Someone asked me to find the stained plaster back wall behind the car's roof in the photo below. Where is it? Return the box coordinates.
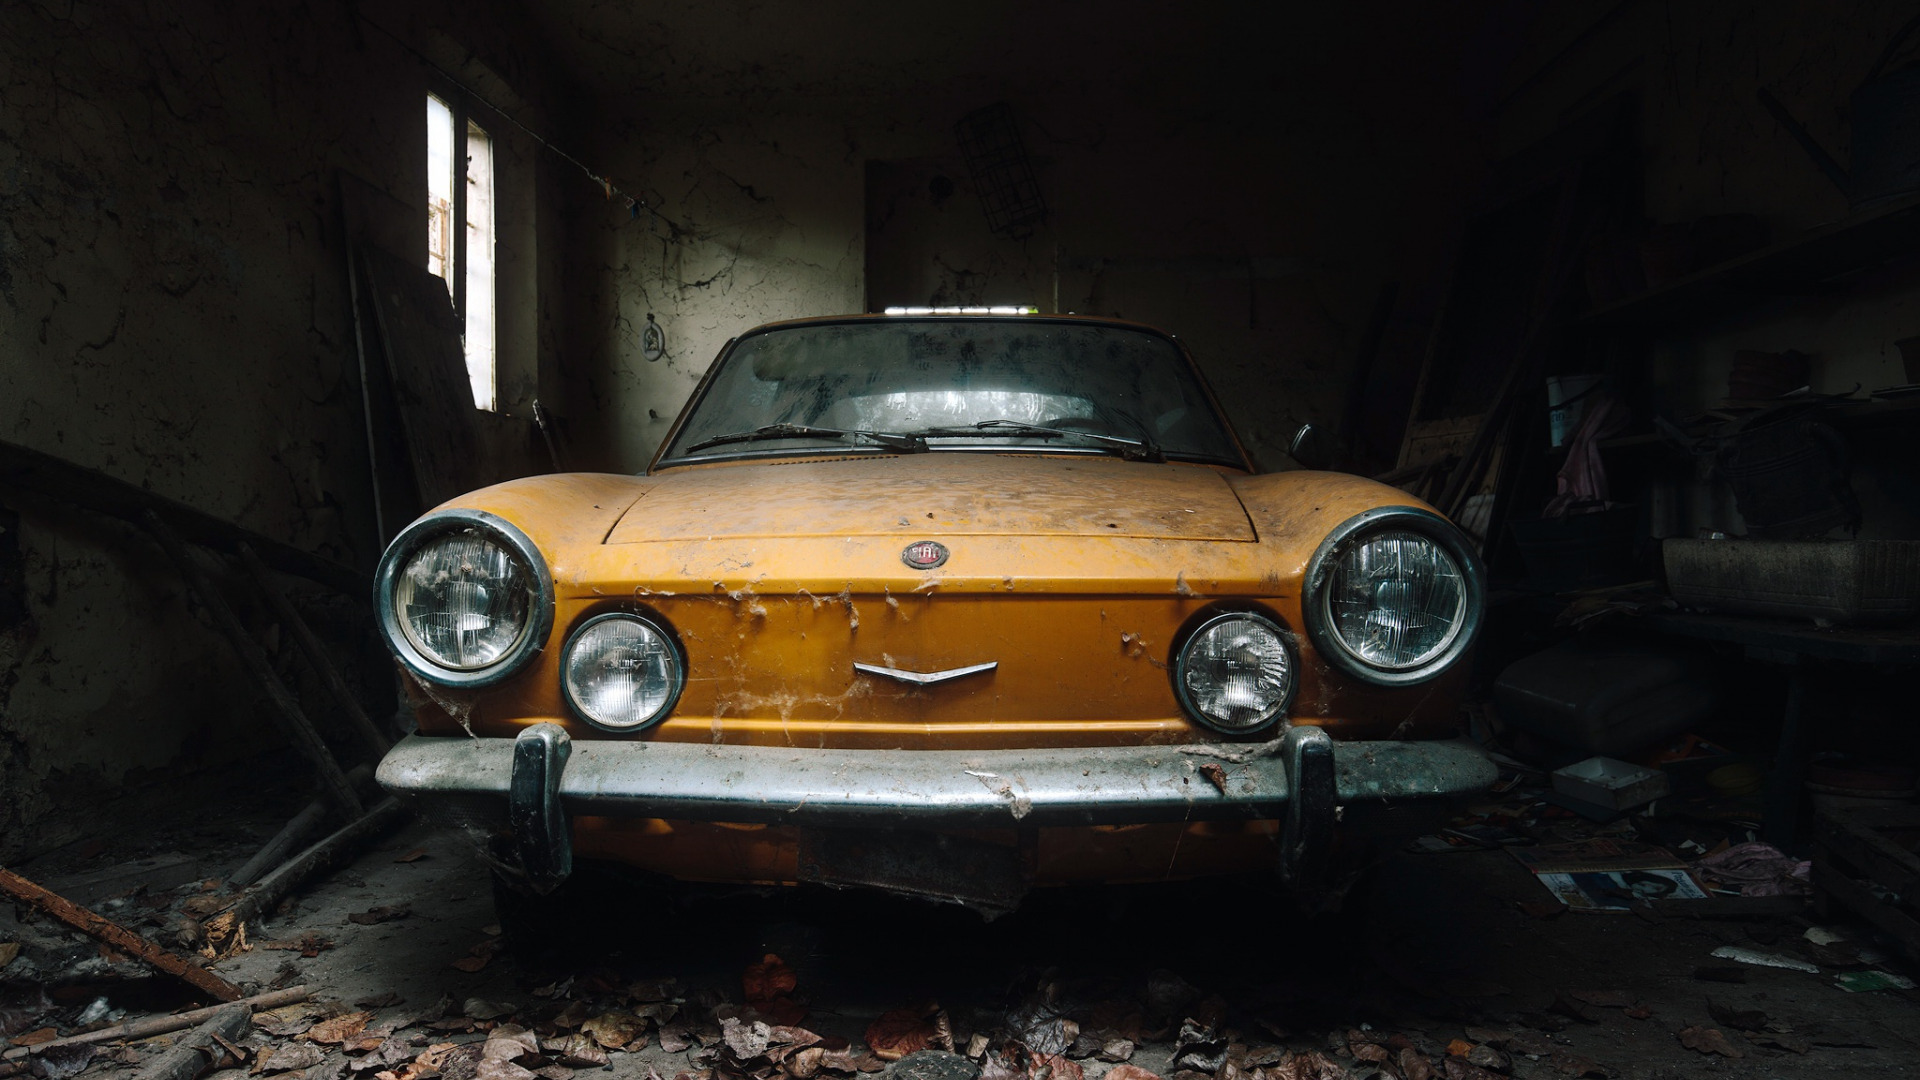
[553,0,1496,471]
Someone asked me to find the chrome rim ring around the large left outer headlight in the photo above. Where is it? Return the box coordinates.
[372,509,553,690]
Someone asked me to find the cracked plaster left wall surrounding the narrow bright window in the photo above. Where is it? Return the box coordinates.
[0,0,576,859]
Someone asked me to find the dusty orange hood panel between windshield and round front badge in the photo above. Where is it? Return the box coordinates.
[607,454,1256,544]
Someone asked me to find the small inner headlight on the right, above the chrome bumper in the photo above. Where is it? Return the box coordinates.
[1173,611,1294,734]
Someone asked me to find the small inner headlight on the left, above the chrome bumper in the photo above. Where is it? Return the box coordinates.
[564,613,685,732]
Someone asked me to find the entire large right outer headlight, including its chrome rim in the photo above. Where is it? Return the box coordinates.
[1308,507,1482,684]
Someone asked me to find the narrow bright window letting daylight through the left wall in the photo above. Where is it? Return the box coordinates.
[426,94,495,411]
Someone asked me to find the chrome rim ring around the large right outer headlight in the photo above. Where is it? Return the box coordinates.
[1302,505,1486,686]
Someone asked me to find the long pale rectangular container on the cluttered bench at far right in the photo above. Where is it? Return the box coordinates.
[1661,540,1920,625]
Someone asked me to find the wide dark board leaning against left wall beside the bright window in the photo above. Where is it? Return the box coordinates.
[361,248,484,507]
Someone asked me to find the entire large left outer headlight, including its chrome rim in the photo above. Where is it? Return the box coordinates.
[374,509,553,688]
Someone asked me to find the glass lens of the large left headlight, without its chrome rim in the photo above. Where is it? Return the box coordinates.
[394,528,534,671]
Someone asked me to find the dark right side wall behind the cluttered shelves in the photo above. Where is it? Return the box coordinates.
[1501,0,1920,538]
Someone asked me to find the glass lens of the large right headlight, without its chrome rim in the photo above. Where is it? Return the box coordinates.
[1327,530,1467,671]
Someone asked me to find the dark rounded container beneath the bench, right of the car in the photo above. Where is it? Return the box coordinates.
[1494,640,1718,755]
